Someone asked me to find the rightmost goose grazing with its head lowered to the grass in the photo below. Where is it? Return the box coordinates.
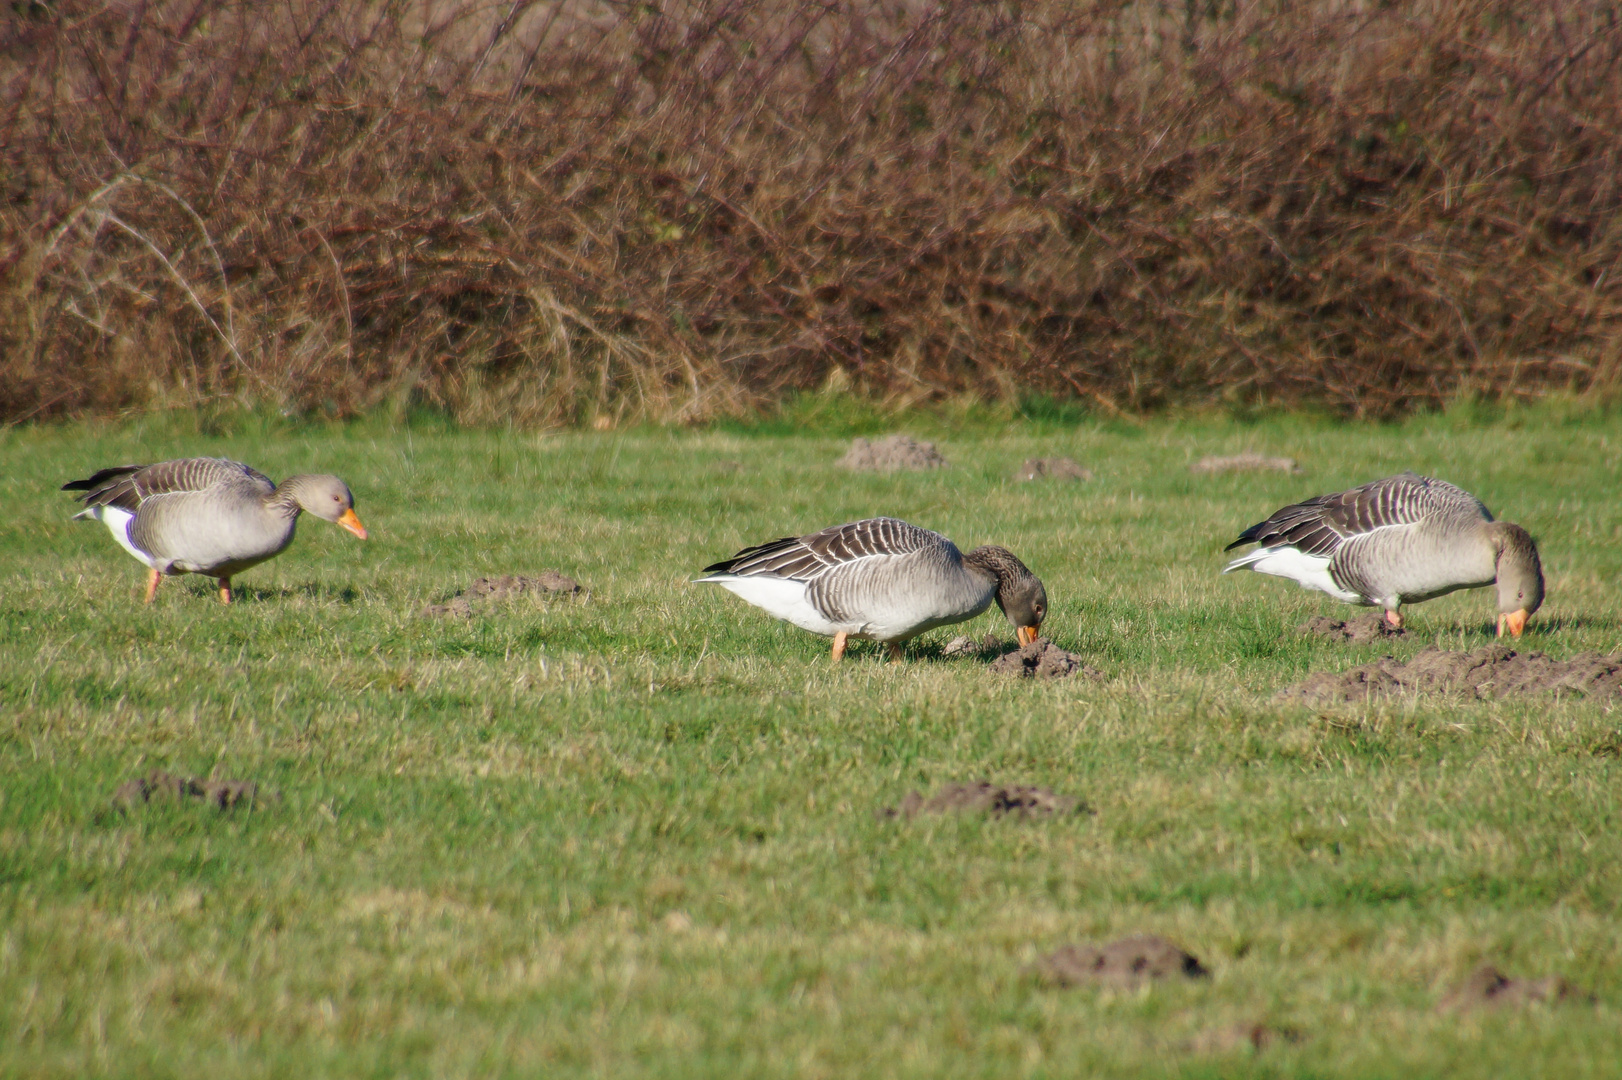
[1223,472,1543,637]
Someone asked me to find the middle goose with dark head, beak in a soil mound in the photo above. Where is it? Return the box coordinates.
[696,517,1048,662]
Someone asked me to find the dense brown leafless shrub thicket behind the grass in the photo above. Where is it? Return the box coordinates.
[0,0,1622,423]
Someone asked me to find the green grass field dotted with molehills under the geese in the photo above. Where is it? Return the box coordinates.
[0,410,1622,1077]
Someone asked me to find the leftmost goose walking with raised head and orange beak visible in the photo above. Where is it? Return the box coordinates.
[62,457,367,603]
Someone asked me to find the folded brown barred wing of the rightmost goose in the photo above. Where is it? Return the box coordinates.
[1225,472,1492,558]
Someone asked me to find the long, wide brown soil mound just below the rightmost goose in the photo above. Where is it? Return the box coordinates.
[1277,645,1622,705]
